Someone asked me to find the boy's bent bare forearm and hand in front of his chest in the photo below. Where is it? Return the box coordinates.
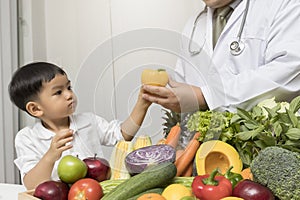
[23,130,73,190]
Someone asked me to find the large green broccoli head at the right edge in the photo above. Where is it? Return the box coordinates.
[250,146,300,200]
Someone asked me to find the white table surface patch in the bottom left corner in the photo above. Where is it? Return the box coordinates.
[0,183,26,200]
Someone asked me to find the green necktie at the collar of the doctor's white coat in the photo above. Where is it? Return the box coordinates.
[213,5,233,47]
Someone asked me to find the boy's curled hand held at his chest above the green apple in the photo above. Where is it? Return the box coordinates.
[47,129,73,161]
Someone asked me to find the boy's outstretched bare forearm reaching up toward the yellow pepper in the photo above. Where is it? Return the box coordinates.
[121,89,151,141]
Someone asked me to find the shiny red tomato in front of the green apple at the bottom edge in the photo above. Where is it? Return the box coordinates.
[68,178,103,200]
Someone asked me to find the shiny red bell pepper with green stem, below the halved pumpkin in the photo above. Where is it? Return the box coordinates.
[192,169,232,200]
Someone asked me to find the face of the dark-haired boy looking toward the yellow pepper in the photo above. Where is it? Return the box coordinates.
[37,74,77,120]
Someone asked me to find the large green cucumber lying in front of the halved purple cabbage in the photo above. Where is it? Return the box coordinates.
[101,162,177,200]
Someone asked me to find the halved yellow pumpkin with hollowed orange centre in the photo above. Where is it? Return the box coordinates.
[195,140,243,175]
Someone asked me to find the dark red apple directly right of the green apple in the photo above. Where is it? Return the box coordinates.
[83,155,110,182]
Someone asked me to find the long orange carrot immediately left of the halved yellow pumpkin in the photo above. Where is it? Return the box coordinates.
[175,132,200,176]
